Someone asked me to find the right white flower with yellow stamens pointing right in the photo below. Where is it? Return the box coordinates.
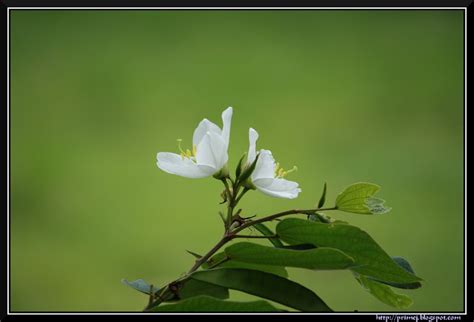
[247,128,301,199]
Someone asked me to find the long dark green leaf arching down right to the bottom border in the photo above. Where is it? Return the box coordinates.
[191,268,331,312]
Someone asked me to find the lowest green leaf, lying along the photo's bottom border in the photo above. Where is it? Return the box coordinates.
[151,295,279,312]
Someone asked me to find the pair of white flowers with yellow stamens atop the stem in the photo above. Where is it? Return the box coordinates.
[156,107,301,199]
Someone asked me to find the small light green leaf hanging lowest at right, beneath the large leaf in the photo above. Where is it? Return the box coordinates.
[356,275,413,309]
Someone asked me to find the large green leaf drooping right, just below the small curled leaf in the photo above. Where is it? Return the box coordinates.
[276,218,421,283]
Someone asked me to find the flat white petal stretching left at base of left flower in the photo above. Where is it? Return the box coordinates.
[156,152,214,178]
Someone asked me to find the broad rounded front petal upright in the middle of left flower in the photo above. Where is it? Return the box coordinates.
[196,132,228,172]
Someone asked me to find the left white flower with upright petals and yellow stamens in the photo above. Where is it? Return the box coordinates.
[156,107,232,178]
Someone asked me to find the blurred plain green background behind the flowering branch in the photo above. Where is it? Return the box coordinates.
[10,10,464,311]
